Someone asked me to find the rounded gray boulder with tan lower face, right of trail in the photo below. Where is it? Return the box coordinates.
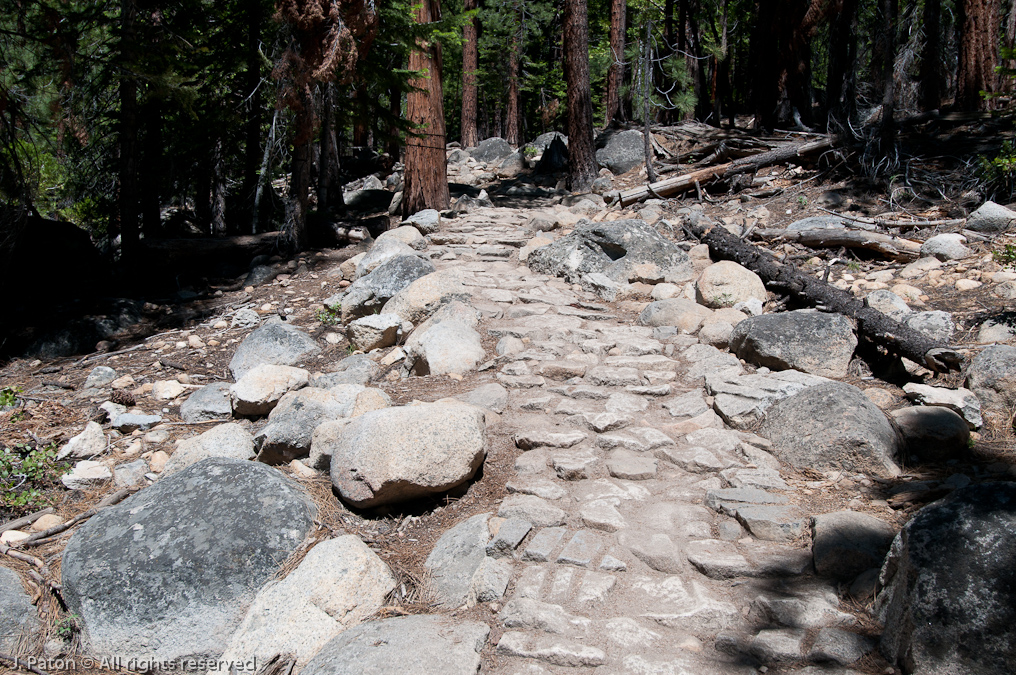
[763,382,900,477]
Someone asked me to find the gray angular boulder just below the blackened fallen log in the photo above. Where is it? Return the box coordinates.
[728,310,858,377]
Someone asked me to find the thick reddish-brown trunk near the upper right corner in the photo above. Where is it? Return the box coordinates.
[956,0,999,110]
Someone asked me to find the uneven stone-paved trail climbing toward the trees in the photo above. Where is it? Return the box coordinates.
[396,208,873,675]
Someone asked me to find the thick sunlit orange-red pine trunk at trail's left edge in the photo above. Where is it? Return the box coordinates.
[402,0,450,216]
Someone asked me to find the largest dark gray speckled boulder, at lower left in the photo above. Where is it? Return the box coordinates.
[61,458,317,661]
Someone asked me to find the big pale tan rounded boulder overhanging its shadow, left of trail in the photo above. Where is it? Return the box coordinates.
[325,404,487,507]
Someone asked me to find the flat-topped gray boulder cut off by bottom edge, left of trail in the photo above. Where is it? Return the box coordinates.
[301,614,491,675]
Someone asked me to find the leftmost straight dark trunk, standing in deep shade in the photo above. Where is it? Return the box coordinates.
[117,0,140,261]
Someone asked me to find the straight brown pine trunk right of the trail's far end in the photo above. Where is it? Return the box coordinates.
[563,0,596,192]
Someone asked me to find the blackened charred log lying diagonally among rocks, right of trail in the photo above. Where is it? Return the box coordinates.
[688,219,963,372]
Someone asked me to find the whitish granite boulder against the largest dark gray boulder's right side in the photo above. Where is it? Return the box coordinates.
[221,535,395,668]
